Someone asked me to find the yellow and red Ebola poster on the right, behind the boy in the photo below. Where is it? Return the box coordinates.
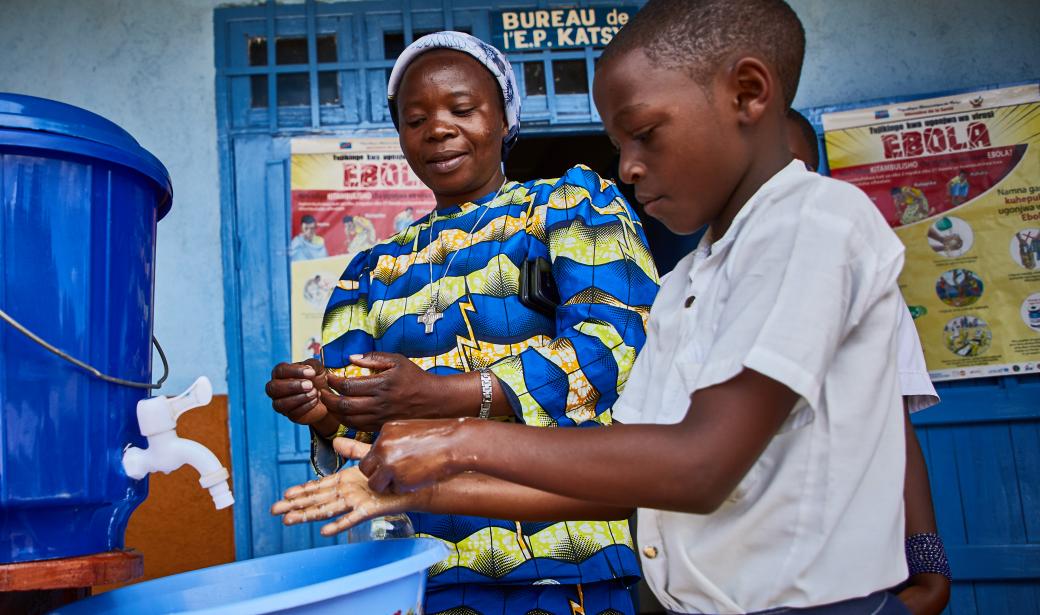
[823,83,1040,381]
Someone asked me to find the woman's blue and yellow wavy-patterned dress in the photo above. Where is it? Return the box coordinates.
[314,165,658,615]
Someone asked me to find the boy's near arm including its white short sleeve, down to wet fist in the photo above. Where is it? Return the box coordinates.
[360,194,902,513]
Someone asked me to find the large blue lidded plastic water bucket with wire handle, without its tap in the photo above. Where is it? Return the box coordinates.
[0,93,173,563]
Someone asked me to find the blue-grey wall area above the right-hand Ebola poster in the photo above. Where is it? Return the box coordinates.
[788,0,1040,108]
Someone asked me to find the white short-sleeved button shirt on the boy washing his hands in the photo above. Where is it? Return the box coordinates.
[614,161,915,613]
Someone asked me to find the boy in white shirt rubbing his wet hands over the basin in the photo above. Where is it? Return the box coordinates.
[272,0,919,613]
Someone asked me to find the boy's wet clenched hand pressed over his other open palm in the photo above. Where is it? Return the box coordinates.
[349,418,483,493]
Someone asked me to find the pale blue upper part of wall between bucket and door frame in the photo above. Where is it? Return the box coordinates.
[0,0,244,393]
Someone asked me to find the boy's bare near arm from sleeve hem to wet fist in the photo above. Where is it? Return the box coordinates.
[360,369,798,518]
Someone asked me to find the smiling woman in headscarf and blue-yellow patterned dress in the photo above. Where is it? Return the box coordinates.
[267,32,657,615]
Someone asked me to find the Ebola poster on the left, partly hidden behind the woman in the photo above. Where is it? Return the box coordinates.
[288,136,434,361]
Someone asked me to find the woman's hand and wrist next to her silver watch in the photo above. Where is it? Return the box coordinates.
[319,352,480,432]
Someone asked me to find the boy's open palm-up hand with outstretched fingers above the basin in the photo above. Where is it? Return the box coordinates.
[270,438,426,536]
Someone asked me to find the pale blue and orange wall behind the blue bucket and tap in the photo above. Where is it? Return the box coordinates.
[0,0,248,591]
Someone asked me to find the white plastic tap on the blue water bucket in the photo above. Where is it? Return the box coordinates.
[123,376,235,510]
